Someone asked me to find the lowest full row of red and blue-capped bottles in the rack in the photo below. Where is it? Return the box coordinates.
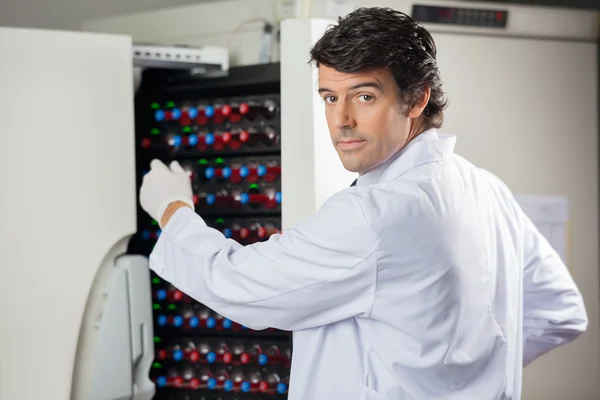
[154,367,289,395]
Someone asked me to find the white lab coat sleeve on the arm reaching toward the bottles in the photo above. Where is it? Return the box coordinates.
[150,189,377,330]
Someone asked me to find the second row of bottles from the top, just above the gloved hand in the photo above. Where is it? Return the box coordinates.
[141,126,279,151]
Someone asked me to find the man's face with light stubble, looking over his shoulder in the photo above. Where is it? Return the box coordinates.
[319,65,410,174]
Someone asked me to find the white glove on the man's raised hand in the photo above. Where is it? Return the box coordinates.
[140,160,194,228]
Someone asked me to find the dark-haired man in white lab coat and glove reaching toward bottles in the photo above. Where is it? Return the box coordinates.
[140,8,587,400]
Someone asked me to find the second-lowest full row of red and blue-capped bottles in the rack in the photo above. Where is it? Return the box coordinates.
[156,340,291,366]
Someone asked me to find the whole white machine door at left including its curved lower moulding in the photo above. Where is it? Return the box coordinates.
[0,28,154,400]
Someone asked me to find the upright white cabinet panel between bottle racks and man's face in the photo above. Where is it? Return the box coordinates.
[281,19,356,230]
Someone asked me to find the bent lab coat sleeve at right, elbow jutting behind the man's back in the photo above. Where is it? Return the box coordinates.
[519,210,588,366]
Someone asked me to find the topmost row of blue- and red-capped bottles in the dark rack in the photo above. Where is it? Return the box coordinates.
[150,99,279,125]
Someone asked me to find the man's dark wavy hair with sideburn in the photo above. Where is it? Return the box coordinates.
[310,7,447,128]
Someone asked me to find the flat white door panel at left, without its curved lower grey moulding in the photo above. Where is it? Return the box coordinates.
[0,28,136,400]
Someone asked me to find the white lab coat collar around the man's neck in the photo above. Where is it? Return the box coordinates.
[356,128,456,186]
